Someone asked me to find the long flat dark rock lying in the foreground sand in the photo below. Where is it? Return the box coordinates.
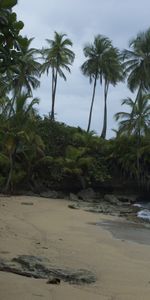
[0,255,96,284]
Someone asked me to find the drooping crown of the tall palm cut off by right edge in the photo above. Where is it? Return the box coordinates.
[122,28,150,99]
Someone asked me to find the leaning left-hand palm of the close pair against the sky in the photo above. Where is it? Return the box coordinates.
[81,35,111,132]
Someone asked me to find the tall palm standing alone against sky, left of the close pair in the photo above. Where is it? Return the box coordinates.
[41,31,75,120]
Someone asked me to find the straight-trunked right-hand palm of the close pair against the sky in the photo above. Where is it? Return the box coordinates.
[101,46,123,139]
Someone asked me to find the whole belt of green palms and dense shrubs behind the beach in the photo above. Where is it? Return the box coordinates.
[0,0,150,192]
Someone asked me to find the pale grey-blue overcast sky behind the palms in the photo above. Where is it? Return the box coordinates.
[14,0,150,138]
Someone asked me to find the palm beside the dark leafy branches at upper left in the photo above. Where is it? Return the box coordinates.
[8,38,40,116]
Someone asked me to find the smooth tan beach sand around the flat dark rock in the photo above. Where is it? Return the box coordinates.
[0,197,150,300]
